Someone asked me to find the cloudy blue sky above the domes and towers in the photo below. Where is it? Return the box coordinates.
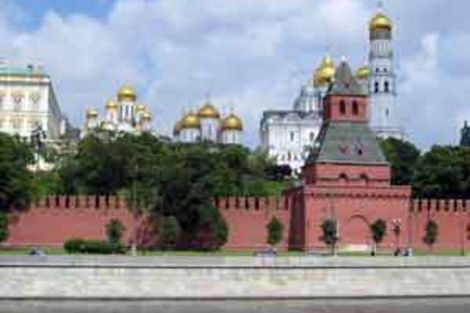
[0,0,470,148]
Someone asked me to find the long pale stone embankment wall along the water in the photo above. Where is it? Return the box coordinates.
[0,257,470,300]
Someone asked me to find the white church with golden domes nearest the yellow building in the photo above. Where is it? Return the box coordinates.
[81,85,152,137]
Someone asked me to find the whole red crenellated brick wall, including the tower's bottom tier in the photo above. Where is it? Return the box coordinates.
[4,193,470,251]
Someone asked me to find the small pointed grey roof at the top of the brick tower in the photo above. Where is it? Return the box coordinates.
[328,61,367,96]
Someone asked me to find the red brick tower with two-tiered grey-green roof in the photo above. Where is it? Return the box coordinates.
[303,61,411,250]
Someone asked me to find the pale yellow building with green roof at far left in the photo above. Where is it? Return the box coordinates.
[0,64,64,143]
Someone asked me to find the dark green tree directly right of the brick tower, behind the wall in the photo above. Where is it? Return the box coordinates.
[380,138,421,185]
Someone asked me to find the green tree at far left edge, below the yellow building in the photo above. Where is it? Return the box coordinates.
[0,133,33,212]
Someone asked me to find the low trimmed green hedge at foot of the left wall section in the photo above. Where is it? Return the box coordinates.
[64,238,125,254]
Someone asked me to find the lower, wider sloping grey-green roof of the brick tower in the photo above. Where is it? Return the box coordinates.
[307,121,388,164]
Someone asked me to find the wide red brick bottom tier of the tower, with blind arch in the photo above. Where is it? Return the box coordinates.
[306,186,411,249]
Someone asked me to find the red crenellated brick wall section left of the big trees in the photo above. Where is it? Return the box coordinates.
[5,196,136,246]
